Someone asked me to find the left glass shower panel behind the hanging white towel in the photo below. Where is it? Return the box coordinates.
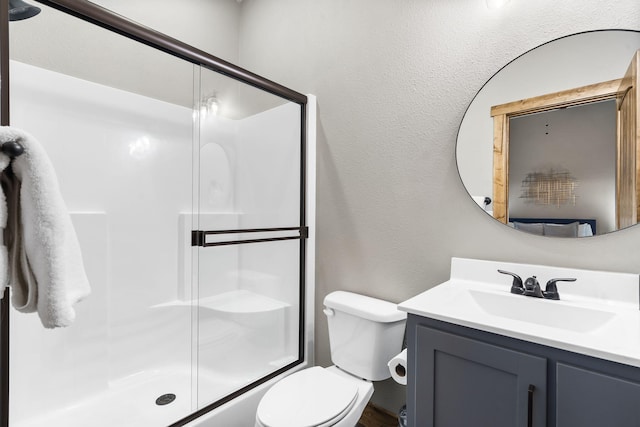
[2,3,196,427]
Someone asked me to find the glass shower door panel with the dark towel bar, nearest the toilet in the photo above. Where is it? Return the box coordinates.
[192,68,306,408]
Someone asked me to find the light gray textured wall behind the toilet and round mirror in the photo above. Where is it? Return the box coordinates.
[240,0,640,410]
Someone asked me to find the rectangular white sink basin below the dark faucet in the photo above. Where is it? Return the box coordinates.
[468,289,615,333]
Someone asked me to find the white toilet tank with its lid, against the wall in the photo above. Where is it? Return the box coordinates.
[324,291,407,381]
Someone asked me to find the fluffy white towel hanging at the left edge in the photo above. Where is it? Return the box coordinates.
[0,127,90,328]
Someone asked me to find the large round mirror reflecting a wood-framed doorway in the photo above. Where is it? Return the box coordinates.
[456,30,640,237]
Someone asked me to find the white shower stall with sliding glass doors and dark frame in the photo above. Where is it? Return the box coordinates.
[0,0,315,427]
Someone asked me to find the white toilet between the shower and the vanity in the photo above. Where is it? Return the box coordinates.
[256,291,406,427]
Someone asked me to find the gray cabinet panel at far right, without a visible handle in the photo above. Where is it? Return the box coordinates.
[555,363,640,427]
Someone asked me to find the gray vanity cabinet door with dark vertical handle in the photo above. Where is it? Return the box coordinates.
[416,325,544,427]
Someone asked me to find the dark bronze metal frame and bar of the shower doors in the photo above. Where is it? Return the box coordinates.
[0,0,308,427]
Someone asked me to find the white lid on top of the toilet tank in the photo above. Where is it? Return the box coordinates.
[324,291,407,323]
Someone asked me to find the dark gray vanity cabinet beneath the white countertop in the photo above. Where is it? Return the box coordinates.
[407,314,640,427]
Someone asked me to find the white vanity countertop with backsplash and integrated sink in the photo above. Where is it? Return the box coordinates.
[398,258,640,367]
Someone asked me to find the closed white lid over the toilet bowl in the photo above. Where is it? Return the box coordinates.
[257,366,358,427]
